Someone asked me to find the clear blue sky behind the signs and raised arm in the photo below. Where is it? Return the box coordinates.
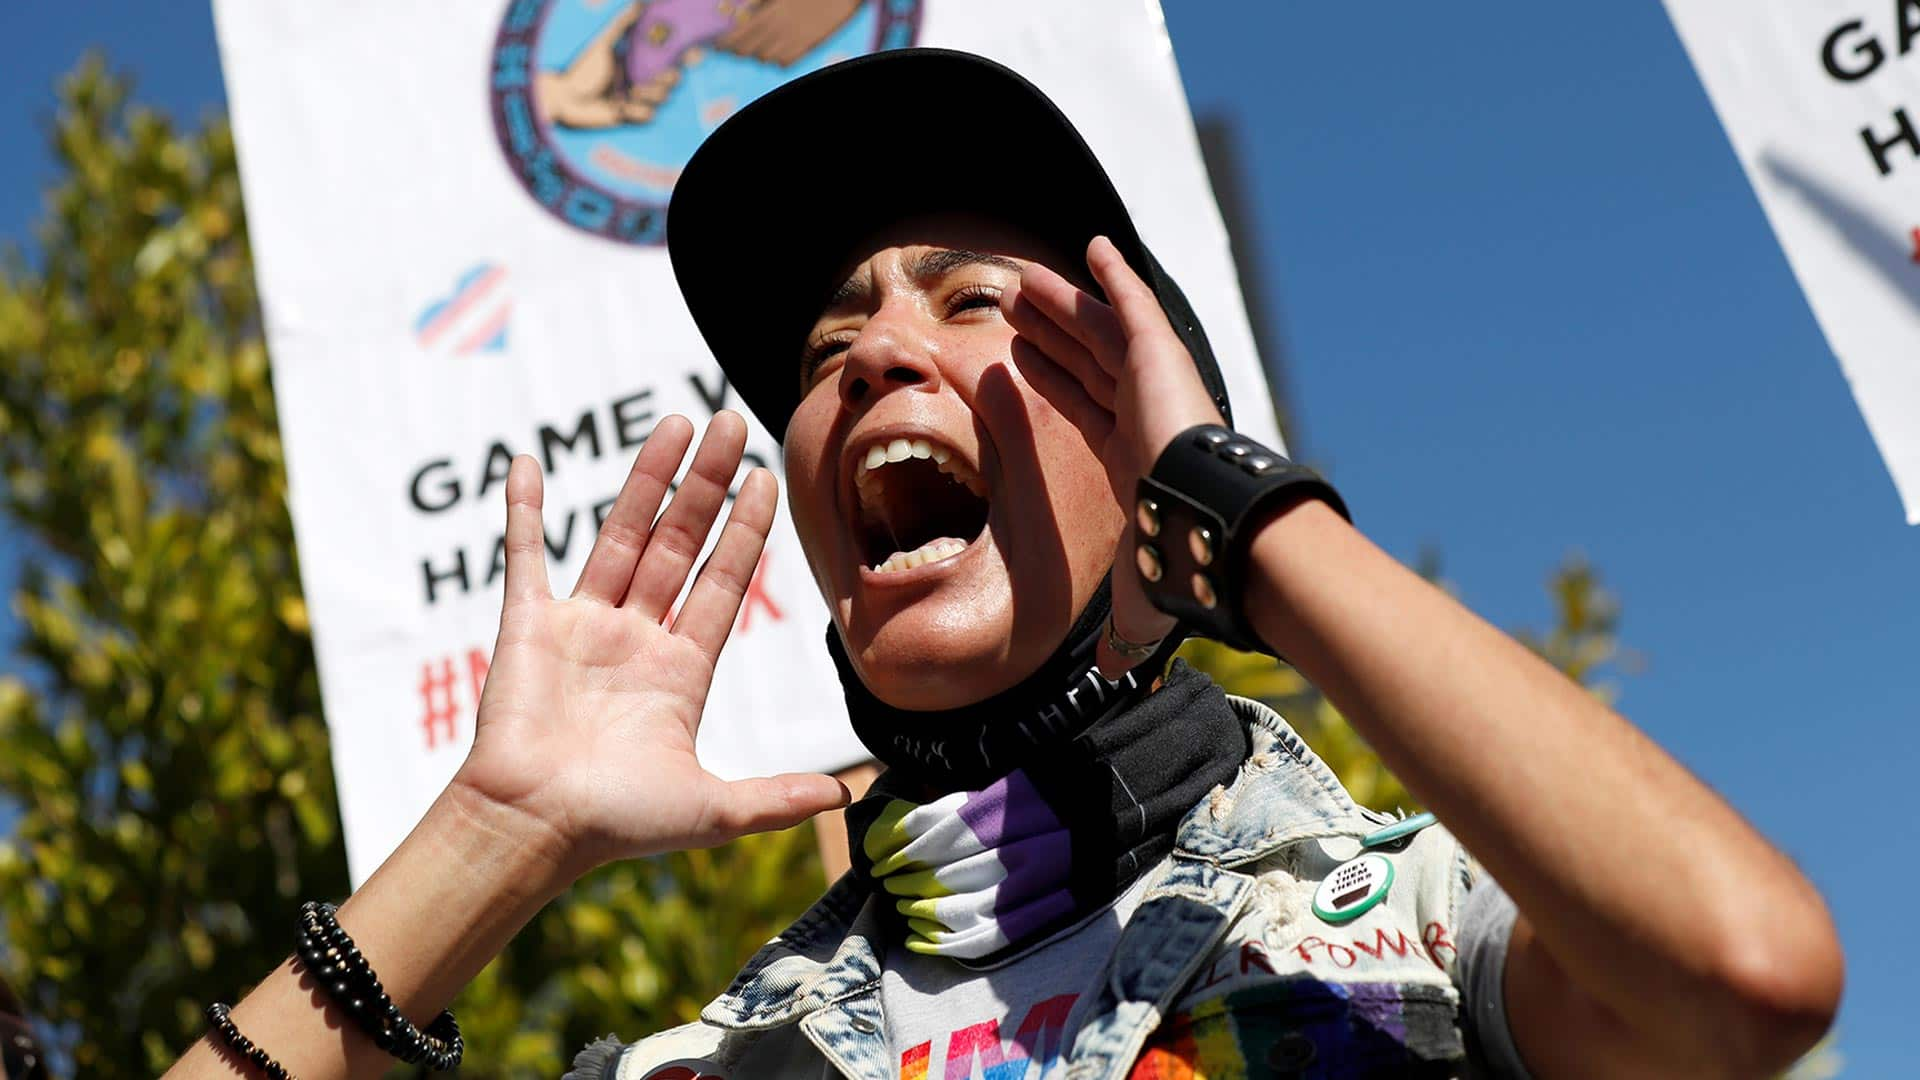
[0,0,1920,1076]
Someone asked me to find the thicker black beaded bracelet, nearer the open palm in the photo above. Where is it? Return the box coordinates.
[300,899,467,1072]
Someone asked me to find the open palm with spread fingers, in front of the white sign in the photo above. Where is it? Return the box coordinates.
[453,411,847,874]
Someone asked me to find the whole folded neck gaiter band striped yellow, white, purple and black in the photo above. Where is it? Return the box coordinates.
[847,661,1248,961]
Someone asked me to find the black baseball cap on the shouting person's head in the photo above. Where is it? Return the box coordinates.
[666,48,1231,438]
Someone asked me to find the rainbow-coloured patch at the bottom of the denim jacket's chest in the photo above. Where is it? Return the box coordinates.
[1129,978,1467,1080]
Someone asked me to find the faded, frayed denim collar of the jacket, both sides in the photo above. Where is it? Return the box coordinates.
[701,696,1394,1037]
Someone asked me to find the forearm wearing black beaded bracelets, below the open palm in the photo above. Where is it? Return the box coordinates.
[167,786,572,1080]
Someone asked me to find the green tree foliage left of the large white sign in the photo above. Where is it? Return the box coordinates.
[0,65,346,1076]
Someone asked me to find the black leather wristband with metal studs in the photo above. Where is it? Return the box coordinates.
[1133,425,1352,653]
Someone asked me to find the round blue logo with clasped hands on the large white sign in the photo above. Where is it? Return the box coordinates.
[488,0,924,244]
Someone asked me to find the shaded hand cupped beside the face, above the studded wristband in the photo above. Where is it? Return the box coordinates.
[1000,236,1221,678]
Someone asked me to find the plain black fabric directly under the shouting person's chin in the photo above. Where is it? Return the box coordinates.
[828,578,1183,792]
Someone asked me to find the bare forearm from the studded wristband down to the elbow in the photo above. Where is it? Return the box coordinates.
[1248,502,1837,1053]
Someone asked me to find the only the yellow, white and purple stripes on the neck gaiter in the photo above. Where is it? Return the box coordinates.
[862,771,1073,959]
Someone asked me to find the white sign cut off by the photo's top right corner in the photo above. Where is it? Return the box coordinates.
[1667,0,1920,525]
